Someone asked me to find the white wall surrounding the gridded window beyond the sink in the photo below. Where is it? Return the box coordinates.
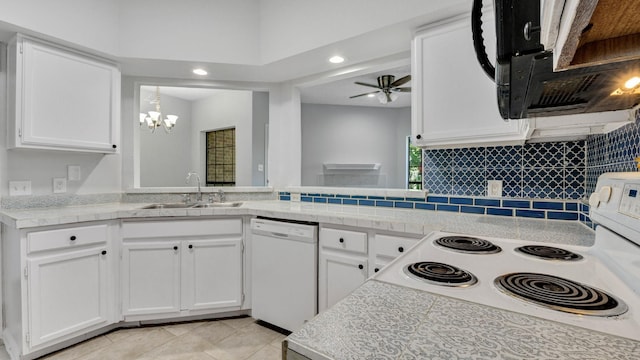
[191,90,253,186]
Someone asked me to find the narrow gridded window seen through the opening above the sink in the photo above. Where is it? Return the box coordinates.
[207,128,236,186]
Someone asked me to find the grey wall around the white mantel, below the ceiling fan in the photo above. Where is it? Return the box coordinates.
[302,104,411,188]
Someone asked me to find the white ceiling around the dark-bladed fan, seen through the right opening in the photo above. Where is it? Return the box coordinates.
[300,65,411,108]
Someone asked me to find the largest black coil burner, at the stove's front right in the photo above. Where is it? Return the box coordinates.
[494,273,628,316]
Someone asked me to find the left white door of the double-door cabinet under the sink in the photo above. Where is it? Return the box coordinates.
[121,241,181,316]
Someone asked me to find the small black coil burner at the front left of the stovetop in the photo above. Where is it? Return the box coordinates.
[405,261,478,287]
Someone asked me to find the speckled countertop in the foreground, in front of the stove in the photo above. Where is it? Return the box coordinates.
[286,280,640,360]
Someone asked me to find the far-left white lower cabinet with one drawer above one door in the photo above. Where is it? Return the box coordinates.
[2,222,117,358]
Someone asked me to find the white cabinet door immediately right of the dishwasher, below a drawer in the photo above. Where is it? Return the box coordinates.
[318,252,367,311]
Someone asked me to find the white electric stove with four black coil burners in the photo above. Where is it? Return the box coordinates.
[373,173,640,341]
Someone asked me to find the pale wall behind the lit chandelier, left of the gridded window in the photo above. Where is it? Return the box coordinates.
[139,90,191,187]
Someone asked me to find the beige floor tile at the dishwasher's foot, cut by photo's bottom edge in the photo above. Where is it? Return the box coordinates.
[207,324,278,360]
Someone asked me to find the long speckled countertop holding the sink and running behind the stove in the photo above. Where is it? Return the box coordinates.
[0,200,594,246]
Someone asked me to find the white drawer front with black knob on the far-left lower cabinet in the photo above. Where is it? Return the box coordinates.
[27,224,109,253]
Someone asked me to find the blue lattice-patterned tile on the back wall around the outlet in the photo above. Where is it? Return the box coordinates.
[423,141,586,200]
